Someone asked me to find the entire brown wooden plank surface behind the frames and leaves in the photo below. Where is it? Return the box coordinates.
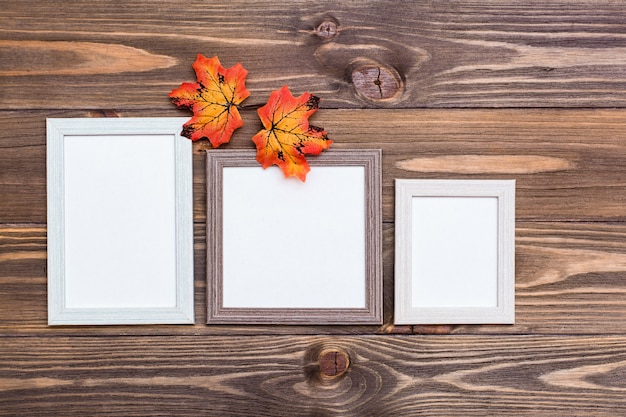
[0,0,626,417]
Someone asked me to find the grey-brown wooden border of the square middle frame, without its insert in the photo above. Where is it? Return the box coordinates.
[206,149,383,325]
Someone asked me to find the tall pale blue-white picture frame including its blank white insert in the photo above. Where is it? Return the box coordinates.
[47,117,194,325]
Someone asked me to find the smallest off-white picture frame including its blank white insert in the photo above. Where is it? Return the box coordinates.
[394,179,515,324]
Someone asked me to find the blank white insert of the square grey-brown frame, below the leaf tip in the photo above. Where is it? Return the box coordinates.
[223,166,366,308]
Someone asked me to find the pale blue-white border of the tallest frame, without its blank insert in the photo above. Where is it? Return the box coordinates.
[46,117,194,325]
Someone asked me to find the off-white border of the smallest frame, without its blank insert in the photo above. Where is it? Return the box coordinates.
[394,179,515,324]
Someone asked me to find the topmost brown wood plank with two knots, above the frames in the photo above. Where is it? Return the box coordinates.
[0,0,626,109]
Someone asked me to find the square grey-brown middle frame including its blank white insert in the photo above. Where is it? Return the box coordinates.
[207,150,382,324]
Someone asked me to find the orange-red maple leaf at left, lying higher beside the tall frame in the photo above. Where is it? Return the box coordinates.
[169,54,250,148]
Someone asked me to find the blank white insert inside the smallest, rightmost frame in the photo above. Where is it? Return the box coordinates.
[411,196,498,308]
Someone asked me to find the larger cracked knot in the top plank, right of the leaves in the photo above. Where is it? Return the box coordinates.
[352,64,402,101]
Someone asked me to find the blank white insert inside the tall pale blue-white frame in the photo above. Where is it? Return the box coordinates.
[63,135,176,308]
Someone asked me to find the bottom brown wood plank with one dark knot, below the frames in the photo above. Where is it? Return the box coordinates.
[0,336,626,417]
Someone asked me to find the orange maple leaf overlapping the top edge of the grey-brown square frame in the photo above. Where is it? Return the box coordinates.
[252,86,333,182]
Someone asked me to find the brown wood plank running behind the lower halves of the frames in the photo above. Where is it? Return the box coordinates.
[0,222,626,335]
